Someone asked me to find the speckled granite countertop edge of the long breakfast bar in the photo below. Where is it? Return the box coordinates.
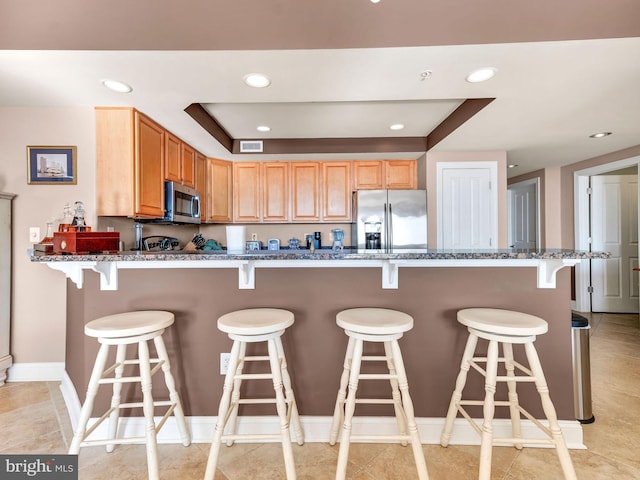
[31,249,611,262]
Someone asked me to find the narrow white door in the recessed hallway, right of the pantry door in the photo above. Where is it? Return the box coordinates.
[507,179,539,249]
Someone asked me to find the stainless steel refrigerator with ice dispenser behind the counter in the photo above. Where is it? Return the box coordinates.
[351,190,427,251]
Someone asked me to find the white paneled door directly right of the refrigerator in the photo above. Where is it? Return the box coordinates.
[437,162,498,249]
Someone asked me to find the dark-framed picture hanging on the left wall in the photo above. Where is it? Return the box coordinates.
[27,146,78,185]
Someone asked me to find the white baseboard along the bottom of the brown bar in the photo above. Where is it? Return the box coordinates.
[60,372,587,449]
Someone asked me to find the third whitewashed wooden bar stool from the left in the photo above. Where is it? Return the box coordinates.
[329,308,429,480]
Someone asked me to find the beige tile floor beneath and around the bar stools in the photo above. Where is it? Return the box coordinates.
[0,314,640,480]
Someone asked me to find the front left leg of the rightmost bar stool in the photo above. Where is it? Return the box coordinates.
[478,340,498,480]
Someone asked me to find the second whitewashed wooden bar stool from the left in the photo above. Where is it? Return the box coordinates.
[204,308,304,480]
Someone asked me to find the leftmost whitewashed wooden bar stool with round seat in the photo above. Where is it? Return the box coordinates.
[69,311,191,480]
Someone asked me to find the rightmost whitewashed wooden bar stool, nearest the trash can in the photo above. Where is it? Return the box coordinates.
[440,308,576,480]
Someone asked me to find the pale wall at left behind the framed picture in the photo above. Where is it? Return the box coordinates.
[0,107,96,363]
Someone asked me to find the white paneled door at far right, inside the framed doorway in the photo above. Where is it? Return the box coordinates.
[591,175,638,313]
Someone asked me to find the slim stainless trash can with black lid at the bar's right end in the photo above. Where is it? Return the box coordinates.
[571,313,596,423]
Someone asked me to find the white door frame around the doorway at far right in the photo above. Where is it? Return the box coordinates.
[573,156,640,312]
